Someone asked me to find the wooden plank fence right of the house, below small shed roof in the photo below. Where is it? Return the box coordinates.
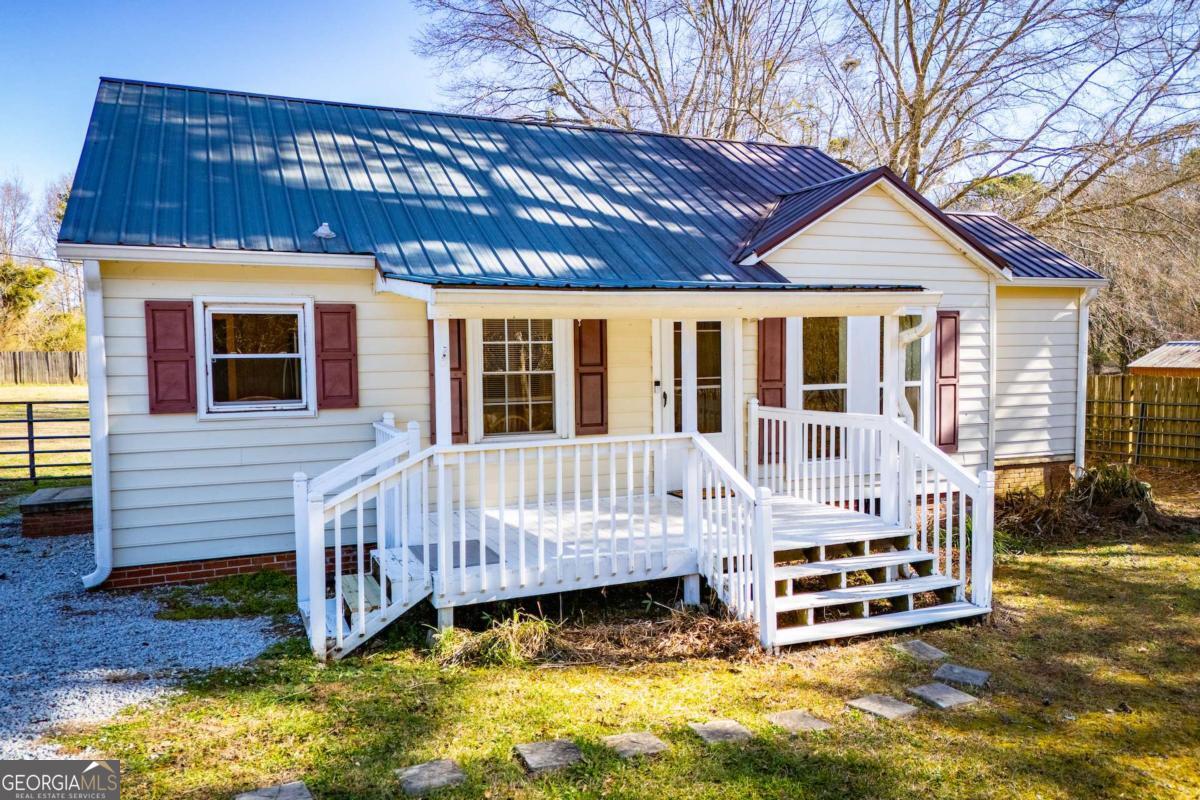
[1087,375,1200,468]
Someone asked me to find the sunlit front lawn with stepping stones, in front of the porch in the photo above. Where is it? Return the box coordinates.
[49,482,1200,800]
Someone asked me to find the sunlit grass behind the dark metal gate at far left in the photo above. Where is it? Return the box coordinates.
[0,384,91,517]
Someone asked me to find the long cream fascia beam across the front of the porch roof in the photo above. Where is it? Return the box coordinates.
[417,288,942,319]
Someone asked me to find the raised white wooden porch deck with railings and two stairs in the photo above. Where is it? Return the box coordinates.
[296,402,991,657]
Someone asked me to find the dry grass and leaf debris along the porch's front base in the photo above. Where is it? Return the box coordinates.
[433,607,761,666]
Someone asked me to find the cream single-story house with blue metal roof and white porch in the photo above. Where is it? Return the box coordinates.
[59,79,1103,657]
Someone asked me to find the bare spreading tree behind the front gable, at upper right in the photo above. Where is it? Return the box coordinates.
[822,0,1200,227]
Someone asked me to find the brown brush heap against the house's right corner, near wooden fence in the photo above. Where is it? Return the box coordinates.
[996,464,1181,549]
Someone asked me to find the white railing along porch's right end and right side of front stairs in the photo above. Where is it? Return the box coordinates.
[749,401,995,608]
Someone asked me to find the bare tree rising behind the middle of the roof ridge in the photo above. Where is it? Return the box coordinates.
[416,0,815,140]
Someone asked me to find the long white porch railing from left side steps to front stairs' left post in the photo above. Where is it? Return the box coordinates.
[295,421,772,657]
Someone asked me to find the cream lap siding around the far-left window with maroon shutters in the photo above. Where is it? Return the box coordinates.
[101,263,428,566]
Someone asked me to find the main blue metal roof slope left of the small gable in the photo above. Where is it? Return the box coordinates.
[59,78,1099,289]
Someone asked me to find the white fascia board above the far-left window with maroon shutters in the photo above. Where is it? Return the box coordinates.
[56,242,376,270]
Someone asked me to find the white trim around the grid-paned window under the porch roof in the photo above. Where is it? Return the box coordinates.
[467,317,576,444]
